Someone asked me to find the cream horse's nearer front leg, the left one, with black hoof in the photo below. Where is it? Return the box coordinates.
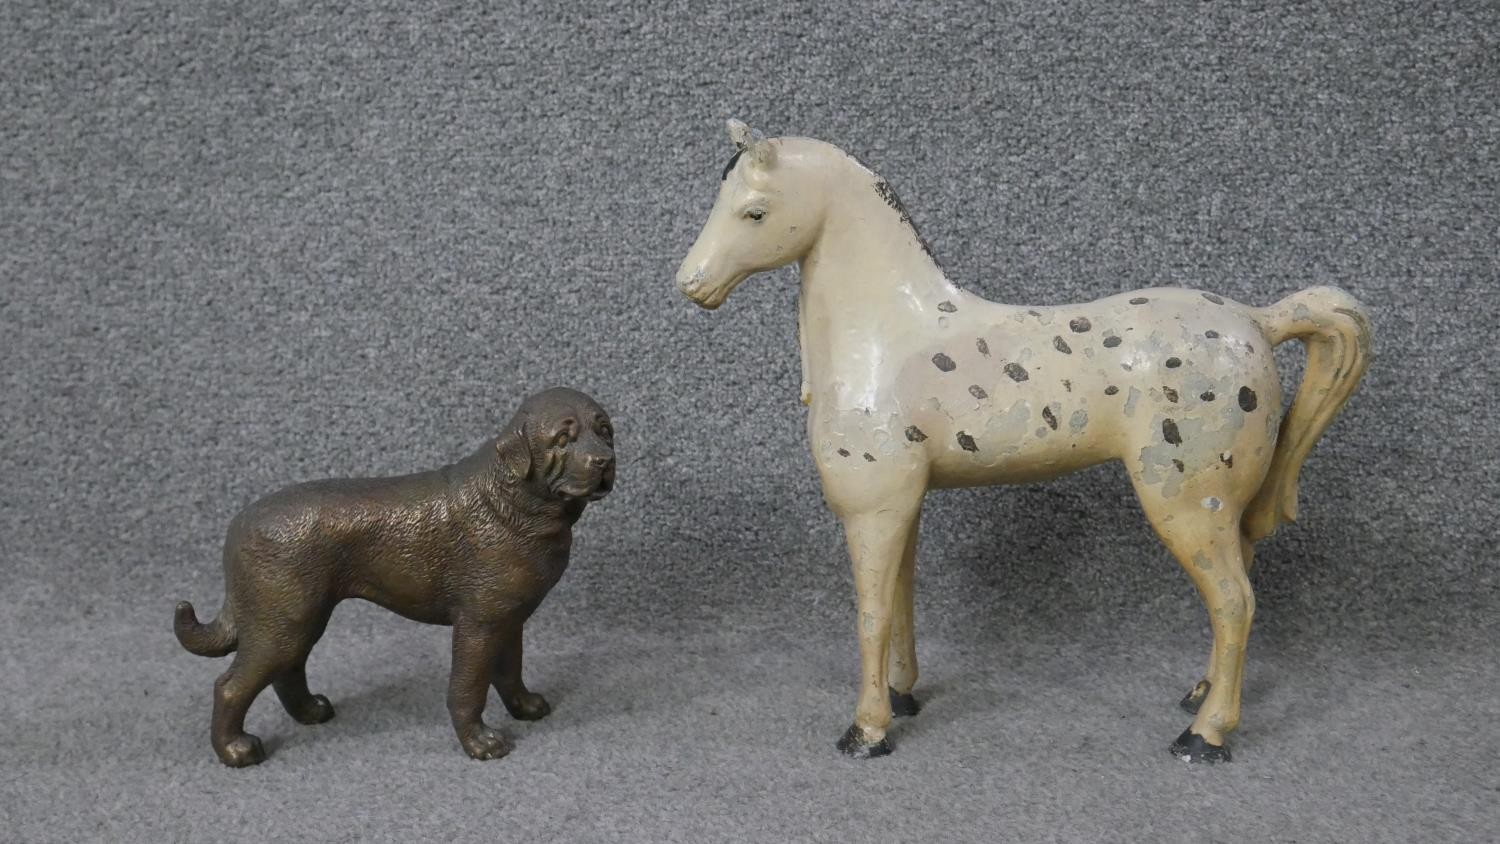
[839,495,921,759]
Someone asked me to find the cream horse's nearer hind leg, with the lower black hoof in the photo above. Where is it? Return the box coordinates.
[1136,481,1256,762]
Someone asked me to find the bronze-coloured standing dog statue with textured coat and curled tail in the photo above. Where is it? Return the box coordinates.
[174,388,615,768]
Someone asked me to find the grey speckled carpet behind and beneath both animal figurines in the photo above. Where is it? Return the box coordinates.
[0,0,1500,841]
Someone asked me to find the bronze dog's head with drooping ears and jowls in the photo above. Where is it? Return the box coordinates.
[495,387,615,501]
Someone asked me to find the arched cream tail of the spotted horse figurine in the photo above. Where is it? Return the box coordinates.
[1242,288,1371,541]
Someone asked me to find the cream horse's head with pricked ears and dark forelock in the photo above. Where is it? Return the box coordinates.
[677,120,825,309]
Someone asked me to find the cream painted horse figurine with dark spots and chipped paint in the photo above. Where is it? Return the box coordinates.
[677,120,1371,762]
